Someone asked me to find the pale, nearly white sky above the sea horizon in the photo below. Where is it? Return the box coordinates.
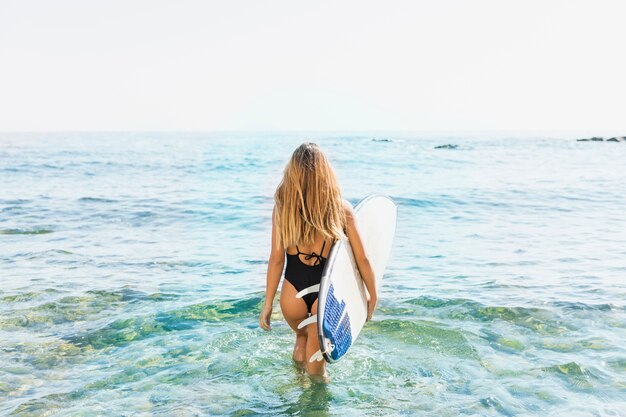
[0,0,626,135]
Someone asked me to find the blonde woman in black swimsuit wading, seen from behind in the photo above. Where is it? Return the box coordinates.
[259,143,378,376]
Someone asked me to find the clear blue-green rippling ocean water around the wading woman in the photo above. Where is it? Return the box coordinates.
[0,133,626,416]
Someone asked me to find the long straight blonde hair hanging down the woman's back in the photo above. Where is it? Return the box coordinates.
[274,142,346,248]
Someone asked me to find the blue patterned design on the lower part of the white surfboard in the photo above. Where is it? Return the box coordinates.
[322,284,352,360]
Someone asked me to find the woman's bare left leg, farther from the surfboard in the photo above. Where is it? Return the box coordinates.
[280,279,308,369]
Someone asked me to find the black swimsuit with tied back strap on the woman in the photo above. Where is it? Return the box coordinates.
[285,241,326,313]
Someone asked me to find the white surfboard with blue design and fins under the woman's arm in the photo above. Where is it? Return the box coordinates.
[303,194,398,363]
